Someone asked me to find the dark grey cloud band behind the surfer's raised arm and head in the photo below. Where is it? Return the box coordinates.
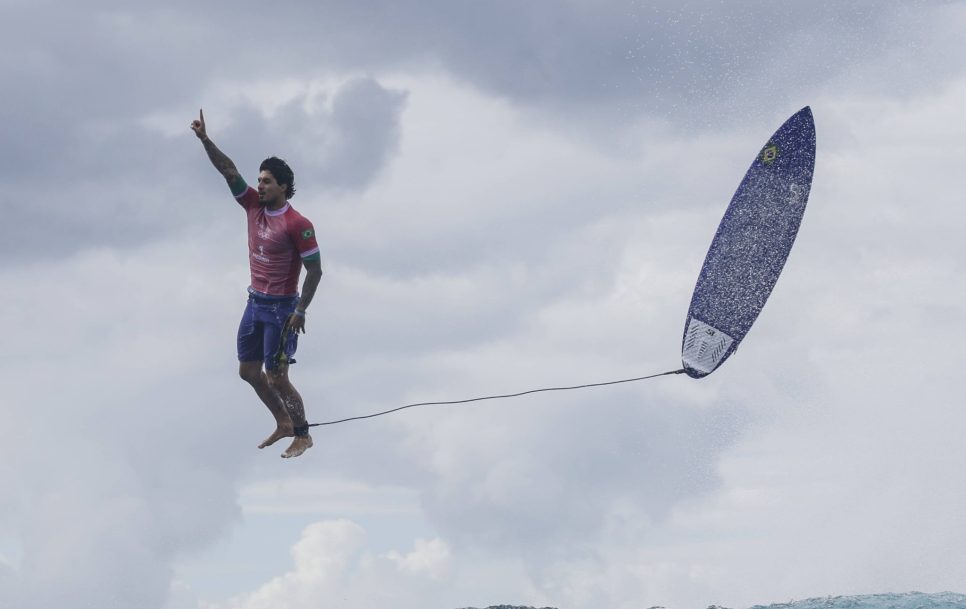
[0,74,405,257]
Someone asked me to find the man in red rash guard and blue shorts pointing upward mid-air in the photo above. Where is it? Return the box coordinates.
[191,112,322,458]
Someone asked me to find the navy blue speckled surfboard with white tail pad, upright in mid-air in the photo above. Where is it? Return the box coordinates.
[681,106,815,378]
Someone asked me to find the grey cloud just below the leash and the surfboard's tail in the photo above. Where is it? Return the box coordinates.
[398,372,737,556]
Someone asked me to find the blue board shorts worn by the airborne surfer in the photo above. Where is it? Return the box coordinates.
[238,292,299,370]
